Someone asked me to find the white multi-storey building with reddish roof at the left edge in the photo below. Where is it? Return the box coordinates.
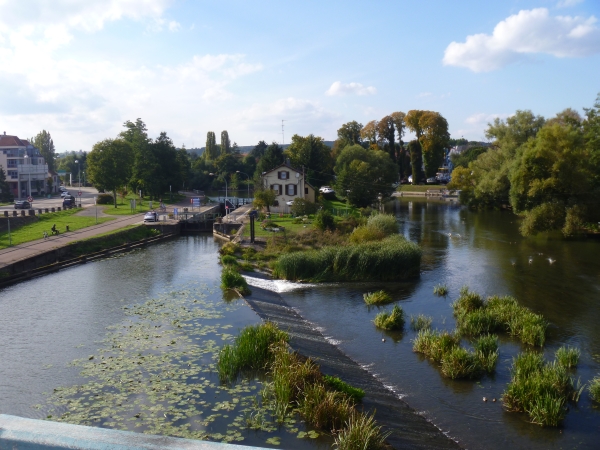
[0,131,49,198]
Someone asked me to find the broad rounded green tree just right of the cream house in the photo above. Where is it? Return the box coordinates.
[335,145,398,207]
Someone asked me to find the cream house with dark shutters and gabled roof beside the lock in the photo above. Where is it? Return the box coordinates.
[261,162,316,212]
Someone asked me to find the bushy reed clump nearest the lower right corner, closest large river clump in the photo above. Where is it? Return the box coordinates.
[502,352,583,427]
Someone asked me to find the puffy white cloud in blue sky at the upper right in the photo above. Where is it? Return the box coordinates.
[443,8,600,72]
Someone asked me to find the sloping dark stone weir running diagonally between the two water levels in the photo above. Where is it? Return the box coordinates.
[245,273,460,450]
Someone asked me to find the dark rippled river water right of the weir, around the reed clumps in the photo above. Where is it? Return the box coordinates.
[244,199,600,449]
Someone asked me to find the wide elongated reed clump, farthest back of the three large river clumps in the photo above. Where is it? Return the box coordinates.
[452,288,548,347]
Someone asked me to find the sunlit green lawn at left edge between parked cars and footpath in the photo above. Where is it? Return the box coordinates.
[0,209,114,248]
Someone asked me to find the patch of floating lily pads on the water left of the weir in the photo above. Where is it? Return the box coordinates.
[36,287,332,448]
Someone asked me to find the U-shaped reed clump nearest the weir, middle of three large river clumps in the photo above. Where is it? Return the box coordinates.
[413,328,498,379]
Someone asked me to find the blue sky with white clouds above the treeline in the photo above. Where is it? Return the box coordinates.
[0,0,600,152]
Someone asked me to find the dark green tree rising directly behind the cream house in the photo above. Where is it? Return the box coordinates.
[285,134,333,186]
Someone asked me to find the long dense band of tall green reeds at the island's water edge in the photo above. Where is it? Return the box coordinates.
[273,235,421,282]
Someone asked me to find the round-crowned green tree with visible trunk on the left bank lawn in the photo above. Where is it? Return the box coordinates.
[88,139,134,208]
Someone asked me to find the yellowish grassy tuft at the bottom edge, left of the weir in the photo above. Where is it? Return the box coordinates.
[335,412,390,450]
